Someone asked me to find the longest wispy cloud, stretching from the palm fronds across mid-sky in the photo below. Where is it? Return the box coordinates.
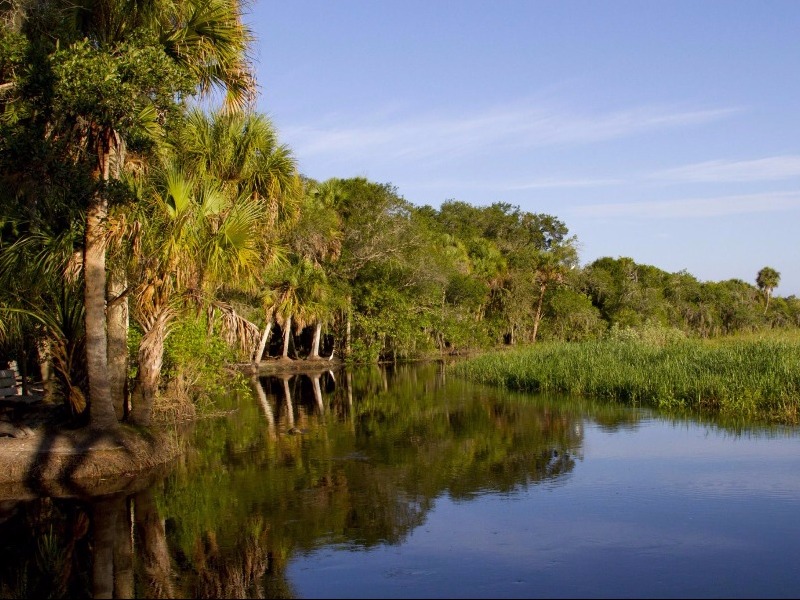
[283,105,738,160]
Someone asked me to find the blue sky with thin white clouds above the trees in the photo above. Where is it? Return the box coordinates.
[245,0,800,297]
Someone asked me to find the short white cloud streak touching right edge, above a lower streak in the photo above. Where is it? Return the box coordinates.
[647,155,800,183]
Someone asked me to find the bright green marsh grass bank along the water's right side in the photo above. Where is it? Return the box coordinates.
[453,334,800,424]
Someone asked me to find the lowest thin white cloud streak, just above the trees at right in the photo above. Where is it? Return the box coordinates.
[571,191,800,219]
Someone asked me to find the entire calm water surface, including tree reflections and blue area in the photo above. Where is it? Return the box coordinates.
[0,364,800,598]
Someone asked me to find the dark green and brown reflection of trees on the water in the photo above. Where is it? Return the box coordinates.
[0,364,630,598]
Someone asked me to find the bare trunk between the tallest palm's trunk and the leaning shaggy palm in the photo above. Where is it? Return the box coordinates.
[107,272,129,421]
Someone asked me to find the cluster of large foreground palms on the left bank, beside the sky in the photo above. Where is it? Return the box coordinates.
[0,0,318,429]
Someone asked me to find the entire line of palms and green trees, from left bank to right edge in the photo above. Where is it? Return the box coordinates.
[0,0,800,430]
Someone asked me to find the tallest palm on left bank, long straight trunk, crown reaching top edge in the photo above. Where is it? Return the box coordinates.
[4,0,254,429]
